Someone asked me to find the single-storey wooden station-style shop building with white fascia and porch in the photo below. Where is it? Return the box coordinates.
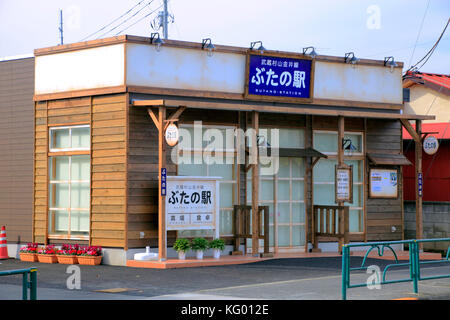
[32,35,433,259]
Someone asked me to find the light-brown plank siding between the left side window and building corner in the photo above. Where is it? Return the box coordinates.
[90,94,127,247]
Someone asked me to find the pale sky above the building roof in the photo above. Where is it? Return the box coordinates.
[0,0,450,74]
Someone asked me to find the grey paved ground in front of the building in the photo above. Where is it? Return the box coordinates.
[0,257,450,300]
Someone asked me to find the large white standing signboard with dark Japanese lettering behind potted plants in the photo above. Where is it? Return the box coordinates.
[166,176,222,238]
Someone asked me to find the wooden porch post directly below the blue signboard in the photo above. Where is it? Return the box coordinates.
[250,111,260,256]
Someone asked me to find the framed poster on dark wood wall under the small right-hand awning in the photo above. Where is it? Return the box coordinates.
[369,169,398,199]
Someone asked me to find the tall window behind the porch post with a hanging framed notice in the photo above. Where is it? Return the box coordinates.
[313,131,364,232]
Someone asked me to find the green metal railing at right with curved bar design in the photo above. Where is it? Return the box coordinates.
[342,238,450,300]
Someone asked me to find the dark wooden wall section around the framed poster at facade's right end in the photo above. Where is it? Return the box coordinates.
[366,119,403,241]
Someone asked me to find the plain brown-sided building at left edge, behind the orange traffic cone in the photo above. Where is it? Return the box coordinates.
[0,55,34,248]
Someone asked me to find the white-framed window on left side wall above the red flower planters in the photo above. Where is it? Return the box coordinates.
[48,126,90,239]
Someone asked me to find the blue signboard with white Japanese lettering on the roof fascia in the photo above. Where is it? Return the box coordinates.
[246,55,313,99]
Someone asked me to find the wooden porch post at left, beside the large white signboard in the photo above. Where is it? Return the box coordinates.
[158,106,167,261]
